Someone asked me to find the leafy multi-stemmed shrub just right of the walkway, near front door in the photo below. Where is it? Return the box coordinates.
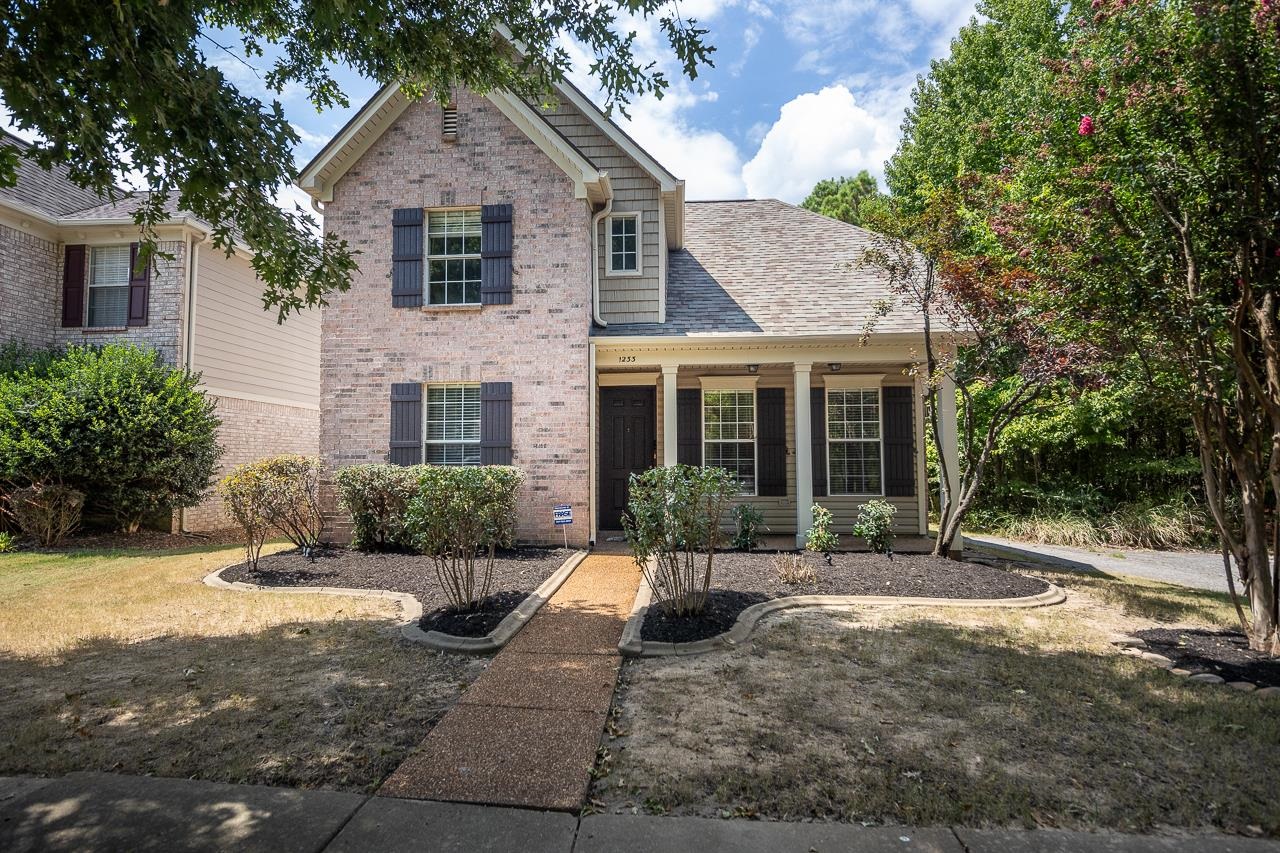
[622,465,739,616]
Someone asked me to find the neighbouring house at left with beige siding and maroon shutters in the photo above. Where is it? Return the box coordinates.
[0,132,320,530]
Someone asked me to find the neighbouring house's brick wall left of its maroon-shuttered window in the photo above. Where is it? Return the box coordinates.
[0,225,63,346]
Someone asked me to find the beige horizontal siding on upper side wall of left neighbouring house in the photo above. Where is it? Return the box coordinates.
[193,246,320,406]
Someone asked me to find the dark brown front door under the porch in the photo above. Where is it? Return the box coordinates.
[599,387,658,530]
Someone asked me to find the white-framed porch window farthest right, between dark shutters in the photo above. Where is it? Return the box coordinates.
[827,386,883,494]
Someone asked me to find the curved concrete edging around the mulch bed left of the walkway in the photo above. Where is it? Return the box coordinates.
[204,551,586,654]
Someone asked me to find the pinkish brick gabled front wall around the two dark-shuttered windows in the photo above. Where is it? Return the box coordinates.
[320,92,590,544]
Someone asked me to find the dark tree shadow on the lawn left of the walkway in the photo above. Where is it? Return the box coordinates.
[0,620,484,790]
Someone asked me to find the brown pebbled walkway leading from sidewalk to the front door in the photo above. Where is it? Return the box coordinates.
[378,553,640,812]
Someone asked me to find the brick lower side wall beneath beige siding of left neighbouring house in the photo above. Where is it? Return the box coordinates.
[183,397,320,532]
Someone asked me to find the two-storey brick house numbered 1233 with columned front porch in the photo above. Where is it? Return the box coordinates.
[298,79,956,544]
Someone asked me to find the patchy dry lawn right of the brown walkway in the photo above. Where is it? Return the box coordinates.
[593,560,1280,835]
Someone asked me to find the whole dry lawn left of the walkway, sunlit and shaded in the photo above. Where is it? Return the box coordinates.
[0,546,484,792]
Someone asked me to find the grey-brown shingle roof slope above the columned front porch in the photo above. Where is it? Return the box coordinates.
[594,199,923,336]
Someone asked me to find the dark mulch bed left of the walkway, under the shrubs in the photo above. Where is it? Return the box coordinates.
[223,548,573,637]
